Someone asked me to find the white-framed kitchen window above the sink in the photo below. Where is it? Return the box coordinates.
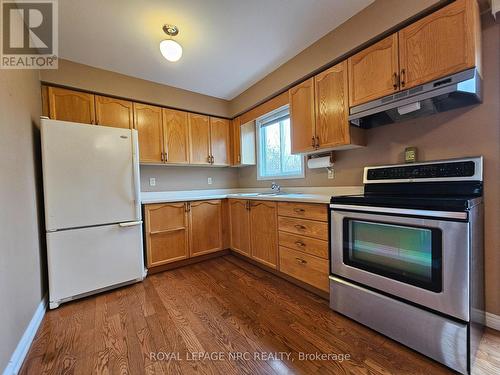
[256,106,304,180]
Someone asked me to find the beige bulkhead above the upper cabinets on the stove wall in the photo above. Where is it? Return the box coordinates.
[230,0,445,115]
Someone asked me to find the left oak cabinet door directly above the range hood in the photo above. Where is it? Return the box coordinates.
[347,34,399,106]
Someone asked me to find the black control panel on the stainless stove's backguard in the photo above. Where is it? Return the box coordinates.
[365,160,476,182]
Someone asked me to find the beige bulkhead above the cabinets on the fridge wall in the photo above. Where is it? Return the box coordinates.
[41,59,229,117]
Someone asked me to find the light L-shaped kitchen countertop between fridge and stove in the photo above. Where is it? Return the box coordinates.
[141,186,363,204]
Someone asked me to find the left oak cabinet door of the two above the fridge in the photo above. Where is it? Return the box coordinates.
[49,87,95,124]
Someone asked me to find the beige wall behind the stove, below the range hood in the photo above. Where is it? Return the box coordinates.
[239,14,500,315]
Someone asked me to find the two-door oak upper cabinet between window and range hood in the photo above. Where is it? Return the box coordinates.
[289,61,365,154]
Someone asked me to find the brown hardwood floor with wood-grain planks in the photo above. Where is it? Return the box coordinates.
[21,255,500,374]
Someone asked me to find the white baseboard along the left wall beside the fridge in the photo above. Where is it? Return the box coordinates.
[3,295,47,375]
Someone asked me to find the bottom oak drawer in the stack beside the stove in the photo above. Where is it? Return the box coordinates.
[280,246,329,291]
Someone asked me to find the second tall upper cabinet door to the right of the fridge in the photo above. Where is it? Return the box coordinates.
[163,108,189,164]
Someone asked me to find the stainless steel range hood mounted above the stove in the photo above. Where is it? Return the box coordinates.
[349,68,482,128]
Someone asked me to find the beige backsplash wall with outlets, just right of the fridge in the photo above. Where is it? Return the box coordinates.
[141,165,238,191]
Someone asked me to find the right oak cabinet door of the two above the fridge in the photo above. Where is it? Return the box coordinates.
[95,95,134,129]
